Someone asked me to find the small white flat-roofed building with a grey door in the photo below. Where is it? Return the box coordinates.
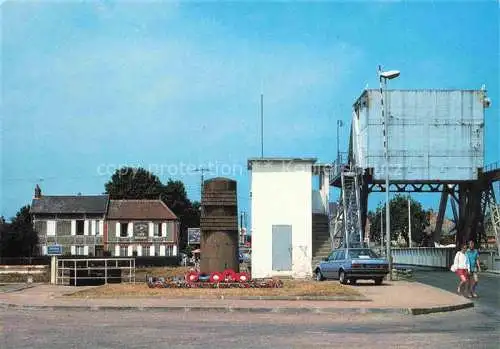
[248,158,329,278]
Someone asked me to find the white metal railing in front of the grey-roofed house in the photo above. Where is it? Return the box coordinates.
[56,258,135,286]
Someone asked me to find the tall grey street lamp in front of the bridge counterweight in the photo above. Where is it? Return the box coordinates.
[378,65,399,281]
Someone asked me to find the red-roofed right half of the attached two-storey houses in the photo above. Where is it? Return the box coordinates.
[104,200,179,257]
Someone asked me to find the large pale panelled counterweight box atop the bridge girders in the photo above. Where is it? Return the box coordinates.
[353,90,484,181]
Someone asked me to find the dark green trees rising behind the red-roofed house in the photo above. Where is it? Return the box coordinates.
[105,167,200,250]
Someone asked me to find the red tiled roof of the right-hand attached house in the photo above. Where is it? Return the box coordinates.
[107,200,177,220]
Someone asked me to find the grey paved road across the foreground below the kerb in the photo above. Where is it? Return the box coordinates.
[0,309,500,349]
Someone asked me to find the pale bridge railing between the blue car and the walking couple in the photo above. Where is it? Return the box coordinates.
[391,247,455,269]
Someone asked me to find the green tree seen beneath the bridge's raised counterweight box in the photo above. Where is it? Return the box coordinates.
[368,195,430,245]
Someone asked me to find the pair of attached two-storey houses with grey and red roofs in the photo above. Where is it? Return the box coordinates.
[30,186,179,257]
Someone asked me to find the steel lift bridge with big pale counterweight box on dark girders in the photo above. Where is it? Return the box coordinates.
[330,88,500,251]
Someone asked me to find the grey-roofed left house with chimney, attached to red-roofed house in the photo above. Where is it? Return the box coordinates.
[31,186,108,256]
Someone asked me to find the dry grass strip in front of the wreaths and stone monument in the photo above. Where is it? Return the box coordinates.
[68,280,360,299]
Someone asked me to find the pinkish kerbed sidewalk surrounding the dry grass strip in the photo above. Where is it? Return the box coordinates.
[0,281,474,315]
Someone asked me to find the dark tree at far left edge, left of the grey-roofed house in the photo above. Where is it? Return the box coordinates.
[0,206,38,257]
